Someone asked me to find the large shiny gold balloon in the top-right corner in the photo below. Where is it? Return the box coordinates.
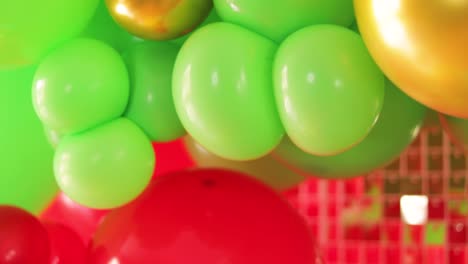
[354,0,468,118]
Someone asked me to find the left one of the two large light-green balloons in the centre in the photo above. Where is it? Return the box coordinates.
[173,23,284,160]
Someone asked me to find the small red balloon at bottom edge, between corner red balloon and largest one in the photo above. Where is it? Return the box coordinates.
[44,222,87,264]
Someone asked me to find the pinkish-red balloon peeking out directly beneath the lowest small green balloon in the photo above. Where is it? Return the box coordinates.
[41,193,109,245]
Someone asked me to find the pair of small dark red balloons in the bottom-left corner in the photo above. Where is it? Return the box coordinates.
[0,206,87,264]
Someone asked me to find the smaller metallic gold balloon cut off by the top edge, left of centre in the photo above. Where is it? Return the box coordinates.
[106,0,213,40]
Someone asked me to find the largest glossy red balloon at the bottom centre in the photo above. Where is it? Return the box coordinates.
[88,169,318,264]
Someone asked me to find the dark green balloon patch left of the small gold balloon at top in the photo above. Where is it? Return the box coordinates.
[81,0,143,52]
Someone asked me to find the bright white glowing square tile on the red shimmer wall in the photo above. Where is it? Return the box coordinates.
[400,195,428,225]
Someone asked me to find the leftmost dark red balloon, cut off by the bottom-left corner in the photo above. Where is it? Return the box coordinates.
[0,206,50,264]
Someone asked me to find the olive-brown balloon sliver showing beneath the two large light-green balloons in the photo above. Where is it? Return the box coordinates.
[184,137,305,190]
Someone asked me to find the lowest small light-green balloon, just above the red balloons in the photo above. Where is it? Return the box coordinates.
[54,118,155,209]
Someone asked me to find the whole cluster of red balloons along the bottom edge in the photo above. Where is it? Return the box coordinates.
[0,169,323,264]
